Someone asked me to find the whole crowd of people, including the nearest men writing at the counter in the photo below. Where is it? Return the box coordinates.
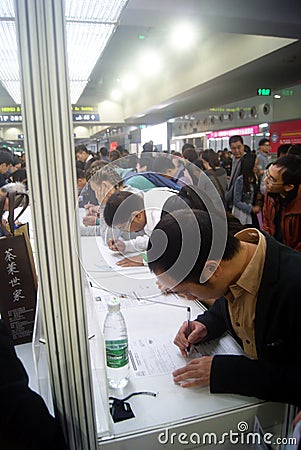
[0,135,301,446]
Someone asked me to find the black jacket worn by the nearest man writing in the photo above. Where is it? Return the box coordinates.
[197,236,301,406]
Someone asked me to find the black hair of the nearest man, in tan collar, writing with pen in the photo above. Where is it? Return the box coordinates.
[147,210,240,284]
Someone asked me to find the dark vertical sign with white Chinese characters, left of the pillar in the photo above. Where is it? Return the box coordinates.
[0,235,37,344]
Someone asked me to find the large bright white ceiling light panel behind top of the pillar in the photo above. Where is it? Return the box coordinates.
[0,0,128,104]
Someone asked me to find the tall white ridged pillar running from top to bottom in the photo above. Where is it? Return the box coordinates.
[15,0,97,450]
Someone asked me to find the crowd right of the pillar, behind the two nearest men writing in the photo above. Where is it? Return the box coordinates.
[76,135,301,251]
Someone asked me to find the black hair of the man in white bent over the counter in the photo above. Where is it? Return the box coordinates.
[103,191,144,227]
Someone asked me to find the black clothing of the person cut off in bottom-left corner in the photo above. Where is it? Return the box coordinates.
[0,320,67,450]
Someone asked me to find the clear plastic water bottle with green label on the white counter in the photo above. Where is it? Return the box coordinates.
[103,297,130,389]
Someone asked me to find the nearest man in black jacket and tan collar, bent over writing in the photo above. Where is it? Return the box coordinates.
[147,210,301,405]
